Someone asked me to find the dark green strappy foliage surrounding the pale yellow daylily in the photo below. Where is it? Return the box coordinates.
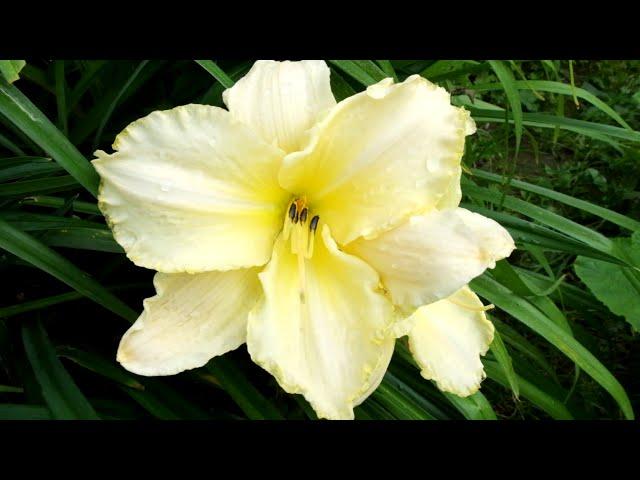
[0,59,640,419]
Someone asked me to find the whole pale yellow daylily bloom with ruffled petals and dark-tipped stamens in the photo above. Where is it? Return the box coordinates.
[93,61,514,419]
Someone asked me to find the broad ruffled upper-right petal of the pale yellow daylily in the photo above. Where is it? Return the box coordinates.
[279,75,476,248]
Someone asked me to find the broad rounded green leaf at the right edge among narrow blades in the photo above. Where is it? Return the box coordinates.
[574,238,640,332]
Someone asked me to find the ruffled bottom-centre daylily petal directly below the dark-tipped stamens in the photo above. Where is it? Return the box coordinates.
[247,225,395,419]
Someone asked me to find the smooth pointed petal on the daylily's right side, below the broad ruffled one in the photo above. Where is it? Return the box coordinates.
[345,208,515,311]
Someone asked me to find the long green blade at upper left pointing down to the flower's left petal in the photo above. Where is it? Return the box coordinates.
[0,80,99,197]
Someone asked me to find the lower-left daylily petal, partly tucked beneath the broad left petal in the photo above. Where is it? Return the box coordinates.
[117,268,262,376]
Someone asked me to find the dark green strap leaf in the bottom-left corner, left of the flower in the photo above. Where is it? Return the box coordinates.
[22,322,99,420]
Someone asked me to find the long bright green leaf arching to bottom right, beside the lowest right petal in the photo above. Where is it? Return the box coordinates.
[470,274,634,420]
